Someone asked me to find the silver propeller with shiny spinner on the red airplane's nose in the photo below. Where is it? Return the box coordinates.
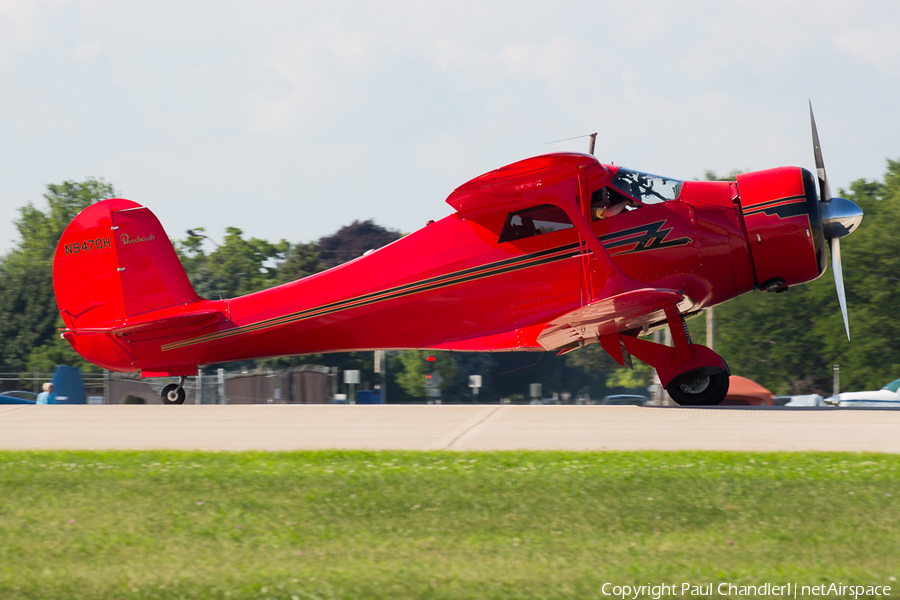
[809,101,863,341]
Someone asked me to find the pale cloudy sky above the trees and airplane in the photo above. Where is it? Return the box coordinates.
[0,0,900,253]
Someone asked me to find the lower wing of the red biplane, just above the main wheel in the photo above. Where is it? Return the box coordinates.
[537,288,694,350]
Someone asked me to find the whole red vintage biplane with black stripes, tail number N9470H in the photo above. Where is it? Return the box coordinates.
[53,108,862,405]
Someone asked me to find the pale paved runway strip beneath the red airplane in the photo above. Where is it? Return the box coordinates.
[0,405,900,453]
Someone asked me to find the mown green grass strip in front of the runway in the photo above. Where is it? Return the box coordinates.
[0,452,900,600]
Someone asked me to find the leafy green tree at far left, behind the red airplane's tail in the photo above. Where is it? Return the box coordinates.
[0,179,116,371]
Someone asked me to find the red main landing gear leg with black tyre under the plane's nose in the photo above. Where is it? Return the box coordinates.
[600,305,731,406]
